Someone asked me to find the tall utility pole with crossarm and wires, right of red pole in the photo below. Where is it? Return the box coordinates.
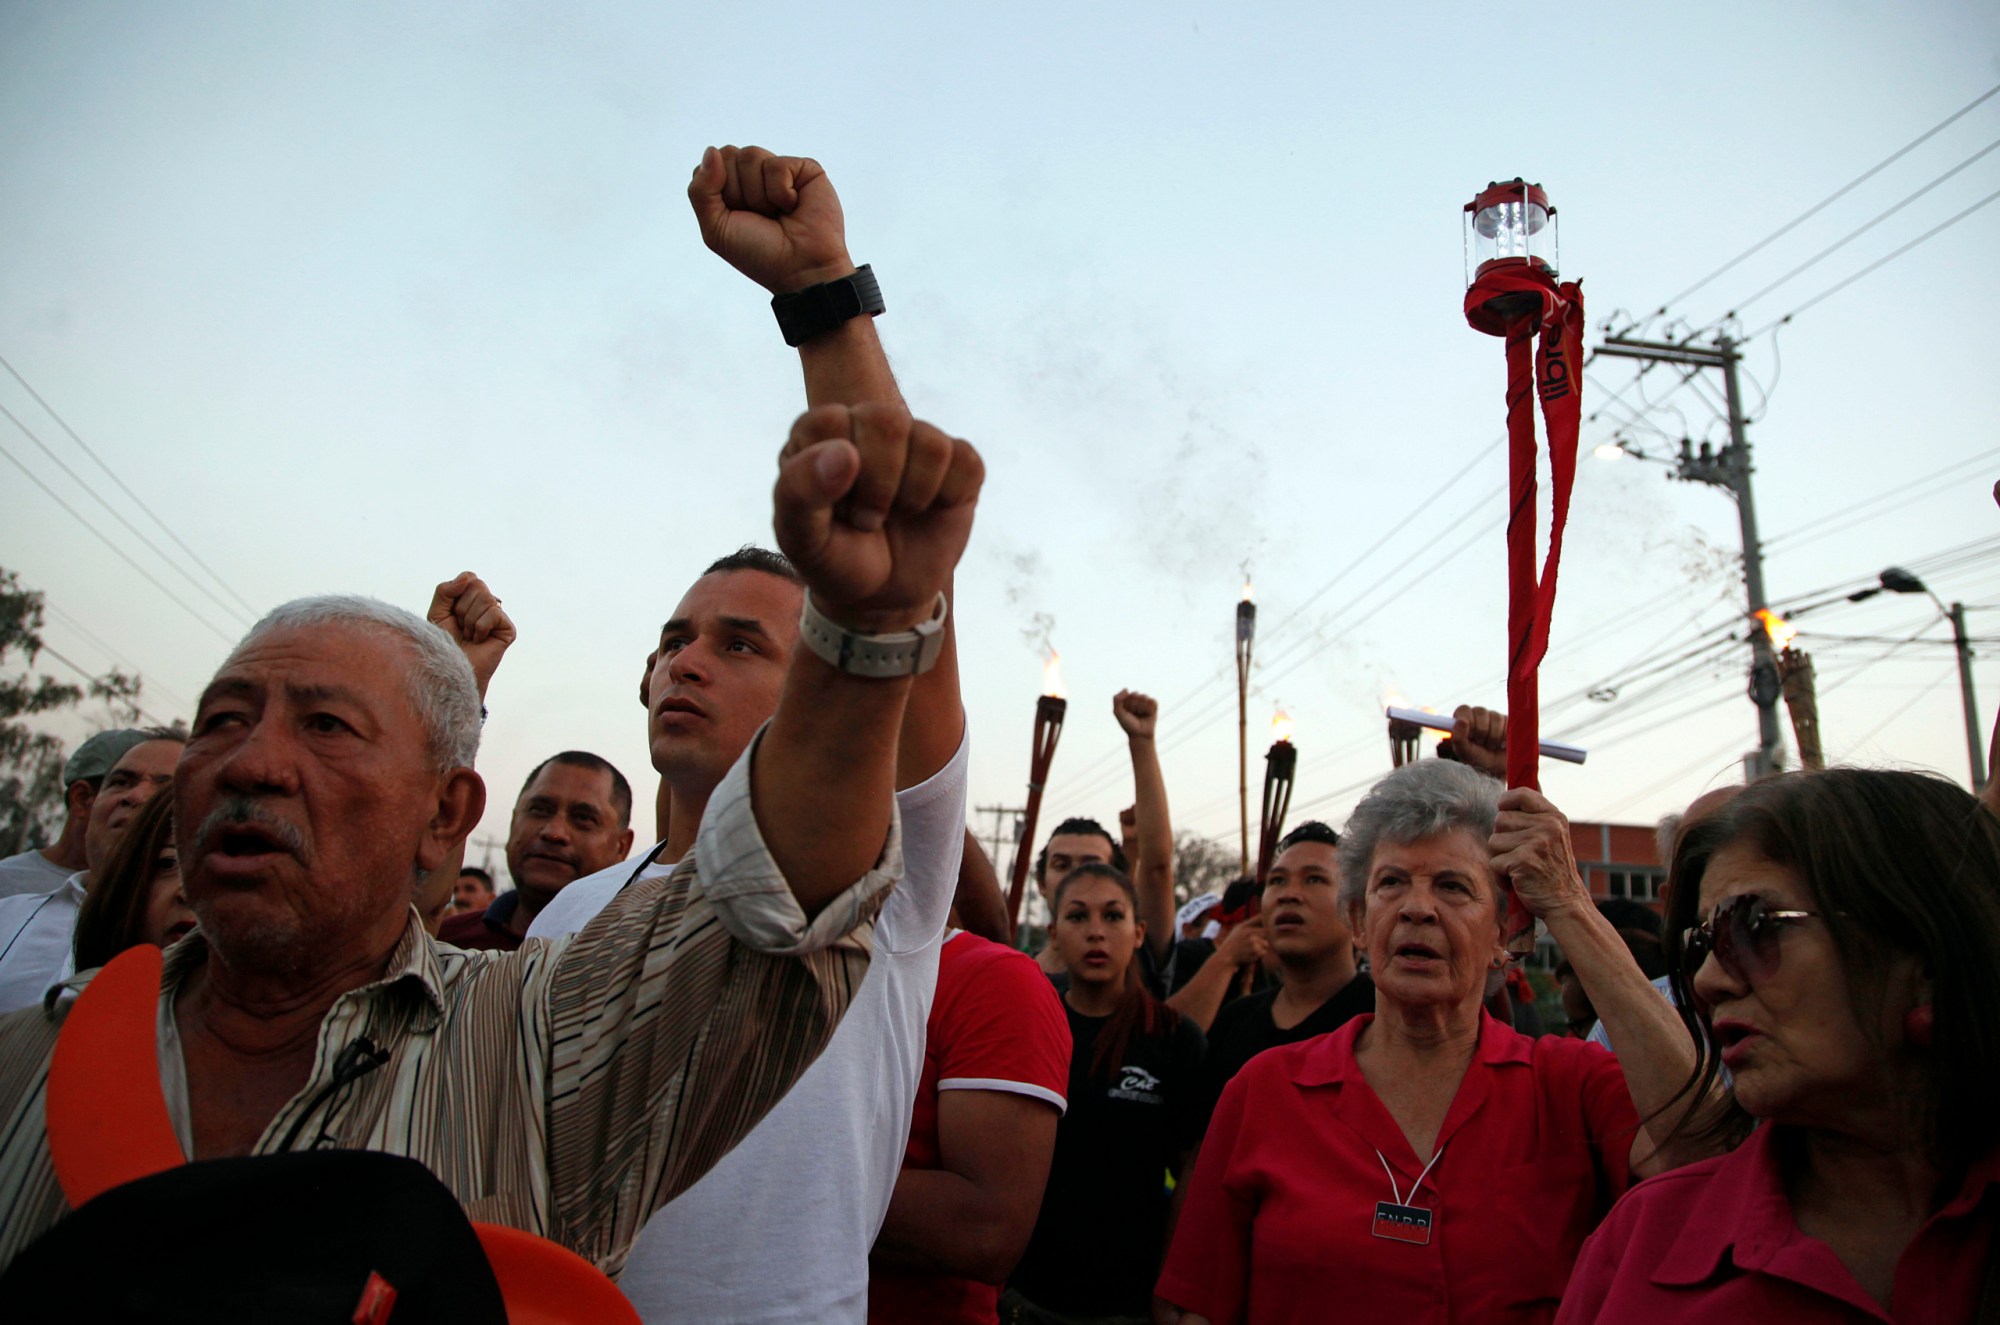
[1598,336,1782,783]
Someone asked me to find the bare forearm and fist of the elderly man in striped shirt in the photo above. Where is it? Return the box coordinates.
[750,404,984,915]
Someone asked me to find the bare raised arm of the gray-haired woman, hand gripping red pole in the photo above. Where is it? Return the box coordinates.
[1488,787,1708,1177]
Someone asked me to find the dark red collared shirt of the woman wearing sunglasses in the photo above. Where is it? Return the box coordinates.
[1556,1125,2000,1325]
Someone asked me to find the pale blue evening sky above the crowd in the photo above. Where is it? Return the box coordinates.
[0,0,2000,892]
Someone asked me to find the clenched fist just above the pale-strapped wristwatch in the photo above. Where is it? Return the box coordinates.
[772,402,986,634]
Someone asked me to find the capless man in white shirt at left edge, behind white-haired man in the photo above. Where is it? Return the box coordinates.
[0,727,186,1013]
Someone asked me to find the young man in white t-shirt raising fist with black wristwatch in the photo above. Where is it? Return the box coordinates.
[528,148,966,1325]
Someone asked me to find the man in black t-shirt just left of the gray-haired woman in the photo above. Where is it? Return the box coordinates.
[1202,819,1374,1117]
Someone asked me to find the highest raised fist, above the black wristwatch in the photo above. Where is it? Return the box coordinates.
[688,148,854,294]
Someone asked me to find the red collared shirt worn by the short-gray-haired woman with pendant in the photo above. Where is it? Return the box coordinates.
[1158,1013,1638,1325]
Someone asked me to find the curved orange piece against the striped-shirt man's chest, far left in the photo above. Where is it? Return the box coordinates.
[44,943,188,1209]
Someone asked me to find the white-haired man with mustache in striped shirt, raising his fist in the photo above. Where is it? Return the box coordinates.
[0,396,982,1273]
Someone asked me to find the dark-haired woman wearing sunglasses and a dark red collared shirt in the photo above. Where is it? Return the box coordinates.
[1558,769,2000,1323]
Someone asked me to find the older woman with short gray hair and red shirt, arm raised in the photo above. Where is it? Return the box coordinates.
[1158,761,1706,1325]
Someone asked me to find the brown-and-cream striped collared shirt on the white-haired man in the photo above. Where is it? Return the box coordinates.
[0,743,902,1273]
